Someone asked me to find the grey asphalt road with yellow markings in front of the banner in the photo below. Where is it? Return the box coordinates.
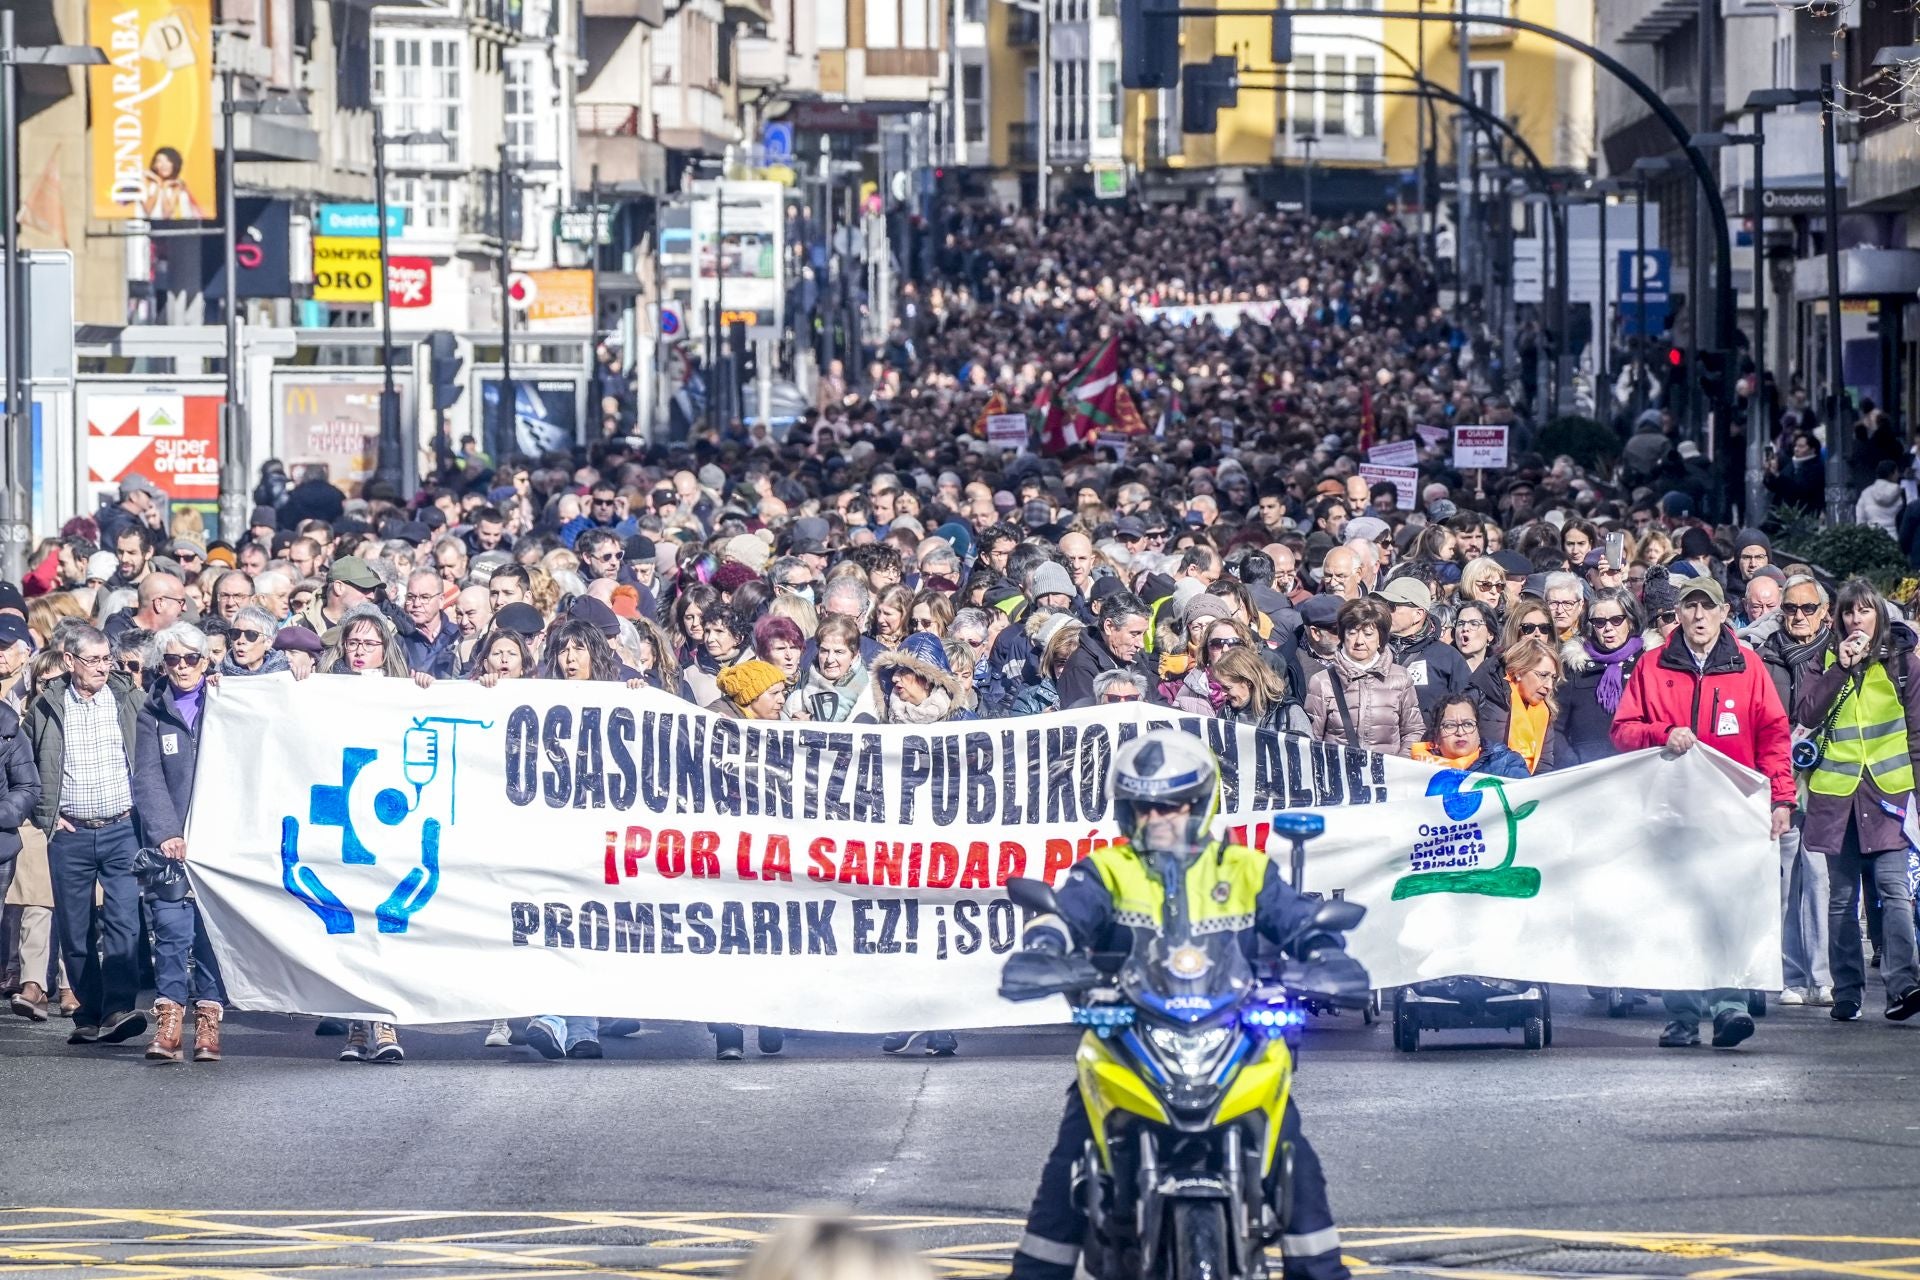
[0,990,1920,1280]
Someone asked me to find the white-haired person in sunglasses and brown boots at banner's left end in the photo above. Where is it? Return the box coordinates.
[132,625,228,1063]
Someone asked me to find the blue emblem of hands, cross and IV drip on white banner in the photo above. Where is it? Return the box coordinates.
[280,716,493,933]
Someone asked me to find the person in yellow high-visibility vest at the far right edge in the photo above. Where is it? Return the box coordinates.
[1793,578,1920,1023]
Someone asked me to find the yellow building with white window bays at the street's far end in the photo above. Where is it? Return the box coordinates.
[958,0,1596,209]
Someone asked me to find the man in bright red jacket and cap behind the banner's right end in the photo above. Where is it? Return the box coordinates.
[1613,578,1793,1050]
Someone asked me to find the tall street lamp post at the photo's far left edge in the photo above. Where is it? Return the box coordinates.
[0,6,108,581]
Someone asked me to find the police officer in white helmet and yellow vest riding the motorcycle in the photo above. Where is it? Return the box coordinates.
[1012,729,1348,1280]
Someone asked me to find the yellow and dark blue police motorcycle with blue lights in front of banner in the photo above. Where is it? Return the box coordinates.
[1000,814,1371,1280]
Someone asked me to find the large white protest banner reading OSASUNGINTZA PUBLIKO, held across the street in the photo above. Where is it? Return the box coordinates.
[188,676,1780,1032]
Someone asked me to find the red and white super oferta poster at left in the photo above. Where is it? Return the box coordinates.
[79,382,223,510]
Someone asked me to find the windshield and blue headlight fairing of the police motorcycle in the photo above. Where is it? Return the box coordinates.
[1119,854,1254,1023]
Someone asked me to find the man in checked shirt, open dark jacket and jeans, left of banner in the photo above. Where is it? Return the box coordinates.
[27,626,146,1044]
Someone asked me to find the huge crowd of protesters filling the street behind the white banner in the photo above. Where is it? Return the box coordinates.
[0,197,1920,1061]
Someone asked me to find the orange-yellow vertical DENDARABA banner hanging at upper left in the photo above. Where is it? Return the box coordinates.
[86,0,215,221]
